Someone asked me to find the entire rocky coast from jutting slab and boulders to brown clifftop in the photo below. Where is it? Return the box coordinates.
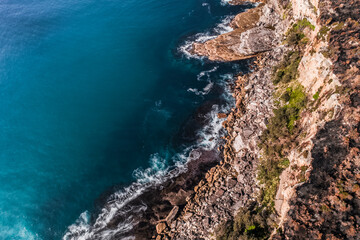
[153,0,360,239]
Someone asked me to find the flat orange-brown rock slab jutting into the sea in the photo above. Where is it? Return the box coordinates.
[193,4,279,61]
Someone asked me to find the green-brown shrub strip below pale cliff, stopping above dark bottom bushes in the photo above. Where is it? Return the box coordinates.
[258,25,315,208]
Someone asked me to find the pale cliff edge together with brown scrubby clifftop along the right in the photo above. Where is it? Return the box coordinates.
[272,1,360,239]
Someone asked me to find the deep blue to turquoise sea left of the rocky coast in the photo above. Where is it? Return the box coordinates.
[0,0,250,240]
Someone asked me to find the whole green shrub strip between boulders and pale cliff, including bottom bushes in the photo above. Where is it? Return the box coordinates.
[215,15,318,240]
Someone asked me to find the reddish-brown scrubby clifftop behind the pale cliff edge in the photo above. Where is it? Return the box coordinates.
[274,0,360,240]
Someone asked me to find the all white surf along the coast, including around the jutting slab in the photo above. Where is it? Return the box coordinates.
[63,5,238,236]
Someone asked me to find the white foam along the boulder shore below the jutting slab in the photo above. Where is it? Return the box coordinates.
[63,72,233,240]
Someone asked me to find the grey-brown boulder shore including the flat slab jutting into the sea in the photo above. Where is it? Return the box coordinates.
[153,3,285,239]
